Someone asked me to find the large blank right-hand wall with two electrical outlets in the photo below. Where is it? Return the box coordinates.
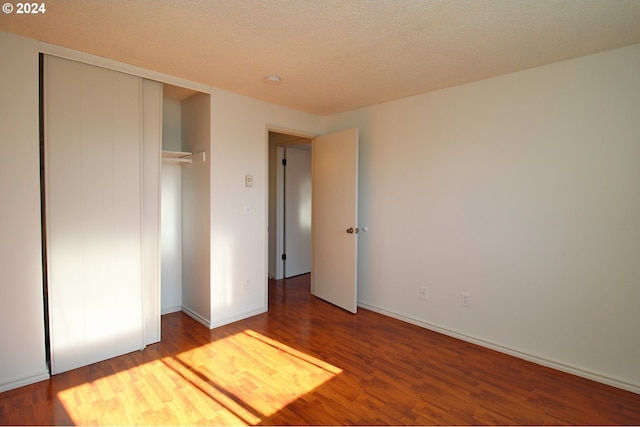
[326,45,640,392]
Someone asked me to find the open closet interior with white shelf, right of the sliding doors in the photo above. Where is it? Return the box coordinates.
[161,84,211,326]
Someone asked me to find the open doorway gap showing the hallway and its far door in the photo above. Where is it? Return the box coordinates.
[268,131,312,279]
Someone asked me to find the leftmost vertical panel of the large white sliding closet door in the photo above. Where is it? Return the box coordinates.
[45,55,87,373]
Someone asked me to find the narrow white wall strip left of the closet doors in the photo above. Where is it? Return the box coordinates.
[0,32,49,392]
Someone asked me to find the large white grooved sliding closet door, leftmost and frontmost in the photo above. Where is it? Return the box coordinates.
[44,57,144,374]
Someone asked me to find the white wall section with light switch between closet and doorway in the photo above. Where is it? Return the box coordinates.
[211,89,323,326]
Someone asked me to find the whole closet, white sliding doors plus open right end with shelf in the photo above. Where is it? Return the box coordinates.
[42,55,210,374]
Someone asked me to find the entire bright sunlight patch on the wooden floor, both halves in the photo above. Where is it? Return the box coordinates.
[57,329,342,425]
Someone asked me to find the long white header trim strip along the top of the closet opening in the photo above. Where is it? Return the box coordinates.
[38,42,211,94]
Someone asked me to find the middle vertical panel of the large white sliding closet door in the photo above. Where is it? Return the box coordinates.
[80,64,116,363]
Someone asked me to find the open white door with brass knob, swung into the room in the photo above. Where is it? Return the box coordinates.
[311,129,358,313]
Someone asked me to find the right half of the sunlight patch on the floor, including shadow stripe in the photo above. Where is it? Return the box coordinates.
[170,330,342,424]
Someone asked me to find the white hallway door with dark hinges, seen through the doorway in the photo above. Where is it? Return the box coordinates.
[284,146,311,277]
